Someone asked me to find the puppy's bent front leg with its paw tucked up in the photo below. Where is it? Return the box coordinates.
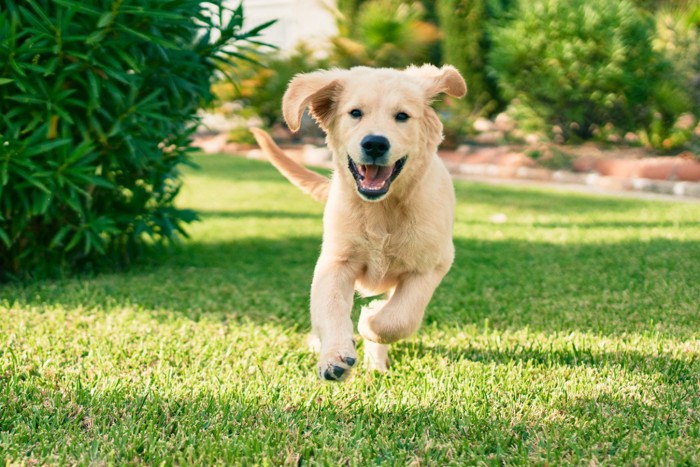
[358,268,447,344]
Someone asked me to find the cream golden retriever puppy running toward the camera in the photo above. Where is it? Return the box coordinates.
[253,65,467,380]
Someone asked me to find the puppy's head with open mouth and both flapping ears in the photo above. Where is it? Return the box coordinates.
[282,65,467,201]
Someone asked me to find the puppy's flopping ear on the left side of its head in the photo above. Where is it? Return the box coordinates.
[282,70,341,132]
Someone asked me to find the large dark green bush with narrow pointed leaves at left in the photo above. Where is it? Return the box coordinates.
[0,0,266,279]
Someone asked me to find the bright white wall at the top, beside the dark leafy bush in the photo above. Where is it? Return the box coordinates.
[238,0,337,51]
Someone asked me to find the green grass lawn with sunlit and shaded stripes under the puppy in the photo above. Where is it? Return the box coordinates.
[0,156,700,465]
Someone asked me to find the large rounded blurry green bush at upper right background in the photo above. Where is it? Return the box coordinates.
[489,0,688,144]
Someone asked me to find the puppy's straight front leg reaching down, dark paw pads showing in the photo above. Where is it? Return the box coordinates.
[311,255,359,381]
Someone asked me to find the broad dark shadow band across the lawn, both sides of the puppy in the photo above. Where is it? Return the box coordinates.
[6,237,700,338]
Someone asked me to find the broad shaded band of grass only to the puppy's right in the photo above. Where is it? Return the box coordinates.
[426,239,700,337]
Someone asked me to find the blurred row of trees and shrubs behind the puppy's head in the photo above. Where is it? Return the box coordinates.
[214,0,700,153]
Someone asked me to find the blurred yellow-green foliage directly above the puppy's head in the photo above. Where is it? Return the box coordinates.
[331,0,439,68]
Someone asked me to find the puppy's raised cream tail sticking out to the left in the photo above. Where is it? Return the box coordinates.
[250,128,331,202]
